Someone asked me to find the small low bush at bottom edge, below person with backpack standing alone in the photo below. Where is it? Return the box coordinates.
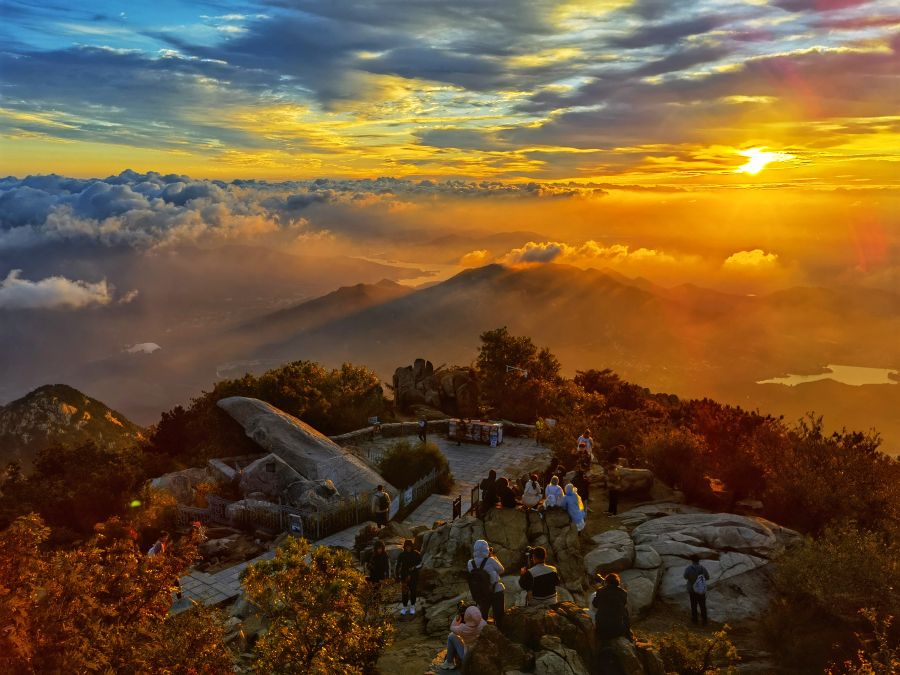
[653,625,740,675]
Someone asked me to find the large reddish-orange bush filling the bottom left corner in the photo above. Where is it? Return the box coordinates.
[0,514,232,675]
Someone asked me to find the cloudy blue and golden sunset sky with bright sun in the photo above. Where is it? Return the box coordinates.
[0,0,900,297]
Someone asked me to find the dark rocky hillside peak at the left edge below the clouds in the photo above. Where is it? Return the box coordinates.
[0,384,143,471]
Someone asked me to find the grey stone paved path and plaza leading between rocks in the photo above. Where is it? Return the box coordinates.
[171,436,551,614]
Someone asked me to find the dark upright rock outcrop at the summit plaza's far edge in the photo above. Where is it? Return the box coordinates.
[393,359,478,417]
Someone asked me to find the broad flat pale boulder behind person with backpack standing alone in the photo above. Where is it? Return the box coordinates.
[631,513,800,622]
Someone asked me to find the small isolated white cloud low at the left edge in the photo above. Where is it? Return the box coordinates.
[0,270,113,309]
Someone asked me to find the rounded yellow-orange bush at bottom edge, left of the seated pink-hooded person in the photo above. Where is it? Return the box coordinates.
[240,537,394,675]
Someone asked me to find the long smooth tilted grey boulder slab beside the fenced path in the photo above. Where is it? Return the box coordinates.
[218,396,398,498]
